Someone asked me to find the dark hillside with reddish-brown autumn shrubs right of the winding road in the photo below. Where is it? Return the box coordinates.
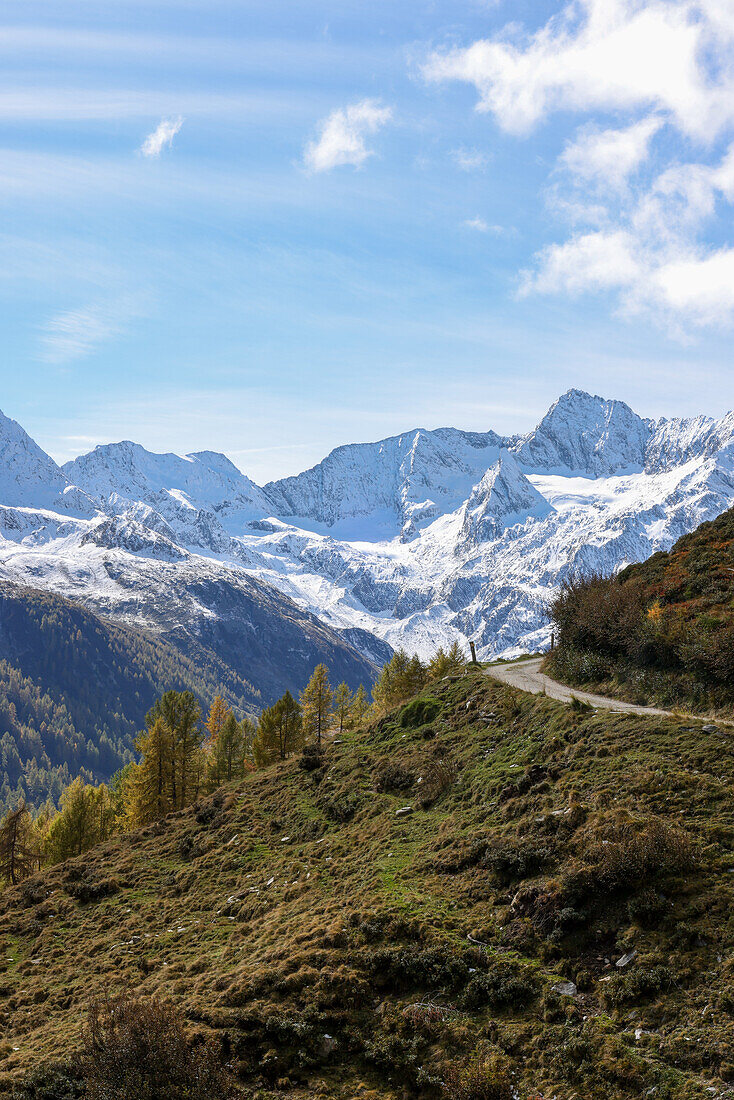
[547,509,734,715]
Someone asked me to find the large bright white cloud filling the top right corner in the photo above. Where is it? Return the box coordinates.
[424,0,734,140]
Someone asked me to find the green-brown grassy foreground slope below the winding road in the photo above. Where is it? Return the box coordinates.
[0,672,734,1100]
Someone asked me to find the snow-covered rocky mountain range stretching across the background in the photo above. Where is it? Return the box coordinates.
[0,389,734,664]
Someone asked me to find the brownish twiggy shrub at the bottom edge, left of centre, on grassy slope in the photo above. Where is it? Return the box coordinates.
[84,994,234,1100]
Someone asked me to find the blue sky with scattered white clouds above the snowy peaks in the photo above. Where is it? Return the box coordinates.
[0,0,734,483]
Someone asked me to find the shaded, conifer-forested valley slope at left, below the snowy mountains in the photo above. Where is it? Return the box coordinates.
[0,583,261,812]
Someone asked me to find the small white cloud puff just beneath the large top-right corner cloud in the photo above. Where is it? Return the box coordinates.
[559,118,662,190]
